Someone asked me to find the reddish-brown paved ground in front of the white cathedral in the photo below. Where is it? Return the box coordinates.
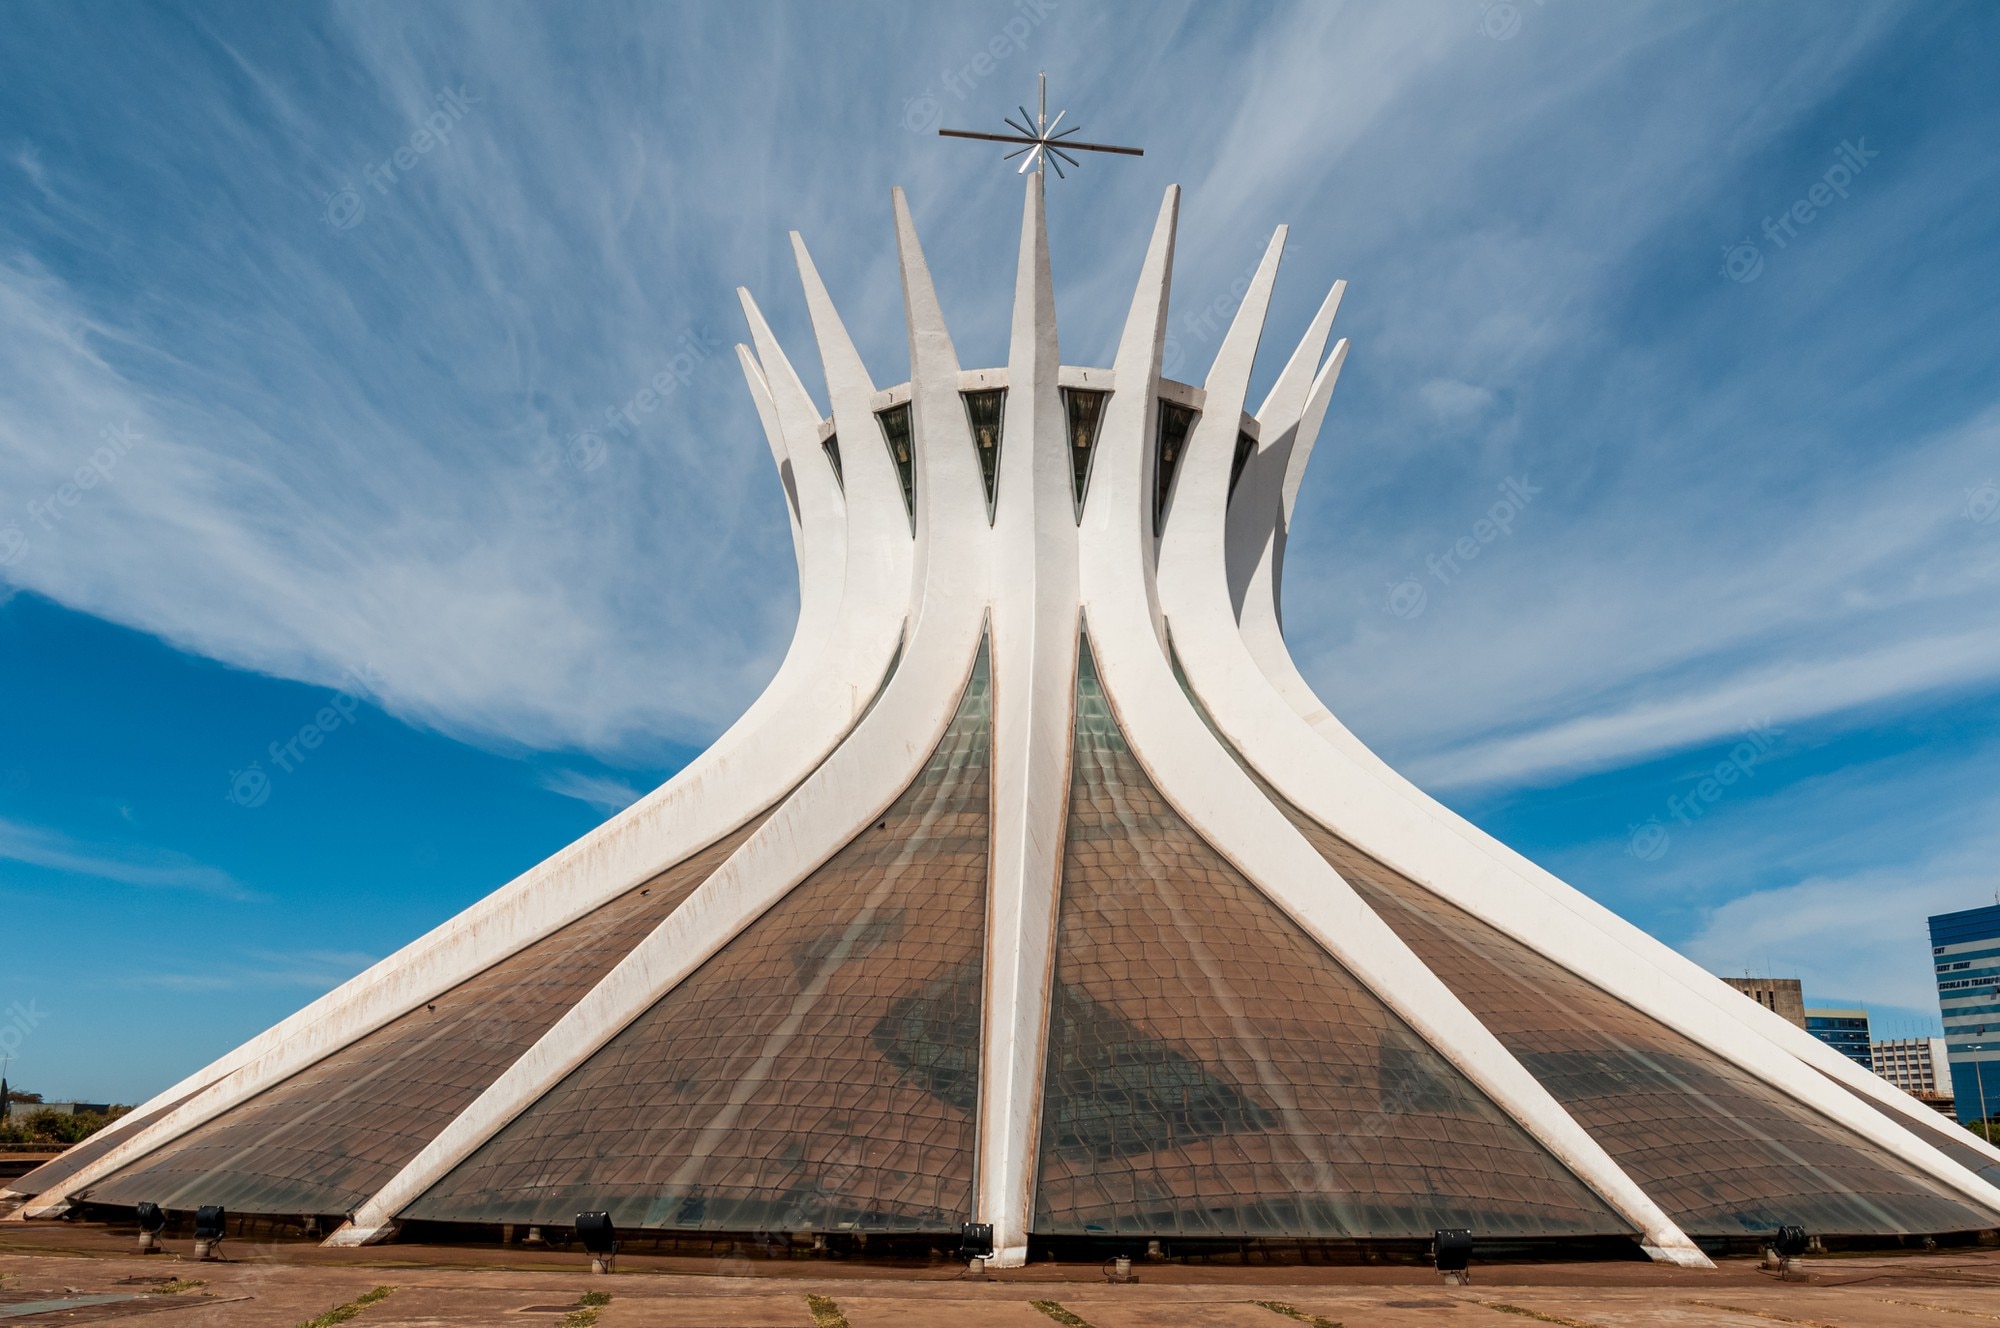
[0,1224,2000,1328]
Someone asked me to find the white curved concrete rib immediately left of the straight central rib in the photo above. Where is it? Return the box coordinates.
[326,192,990,1246]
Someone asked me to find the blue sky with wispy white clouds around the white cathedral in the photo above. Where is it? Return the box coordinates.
[0,0,2000,1100]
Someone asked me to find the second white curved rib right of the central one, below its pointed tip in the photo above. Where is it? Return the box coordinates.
[1160,306,2000,1212]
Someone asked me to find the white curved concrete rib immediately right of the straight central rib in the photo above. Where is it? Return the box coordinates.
[1080,190,1708,1266]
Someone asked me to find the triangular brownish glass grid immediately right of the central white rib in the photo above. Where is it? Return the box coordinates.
[1034,644,1630,1238]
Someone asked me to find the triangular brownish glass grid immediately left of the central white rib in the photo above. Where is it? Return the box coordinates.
[404,648,992,1232]
